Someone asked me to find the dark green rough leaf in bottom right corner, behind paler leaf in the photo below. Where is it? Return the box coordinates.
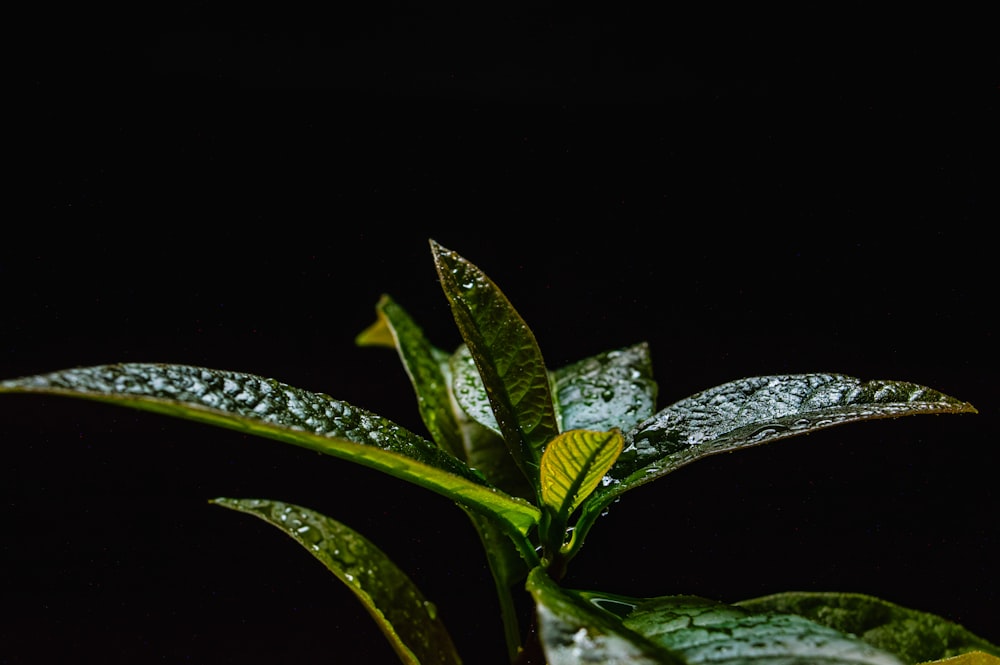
[736,592,1000,663]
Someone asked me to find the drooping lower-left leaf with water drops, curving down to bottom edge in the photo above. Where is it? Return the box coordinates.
[212,497,462,665]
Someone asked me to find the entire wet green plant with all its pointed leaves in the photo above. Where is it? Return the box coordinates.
[0,240,1000,665]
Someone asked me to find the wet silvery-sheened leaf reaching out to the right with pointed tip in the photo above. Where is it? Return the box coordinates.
[587,374,976,511]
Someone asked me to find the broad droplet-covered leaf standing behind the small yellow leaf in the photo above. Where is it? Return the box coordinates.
[552,342,657,431]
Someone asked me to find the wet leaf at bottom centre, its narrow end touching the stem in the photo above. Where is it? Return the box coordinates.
[526,568,685,665]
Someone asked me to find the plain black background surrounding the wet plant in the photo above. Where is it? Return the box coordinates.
[0,10,1000,665]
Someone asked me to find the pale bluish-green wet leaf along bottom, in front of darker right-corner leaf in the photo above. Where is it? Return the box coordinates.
[624,596,904,665]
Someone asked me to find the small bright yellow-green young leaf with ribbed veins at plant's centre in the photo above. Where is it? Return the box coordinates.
[541,429,623,521]
